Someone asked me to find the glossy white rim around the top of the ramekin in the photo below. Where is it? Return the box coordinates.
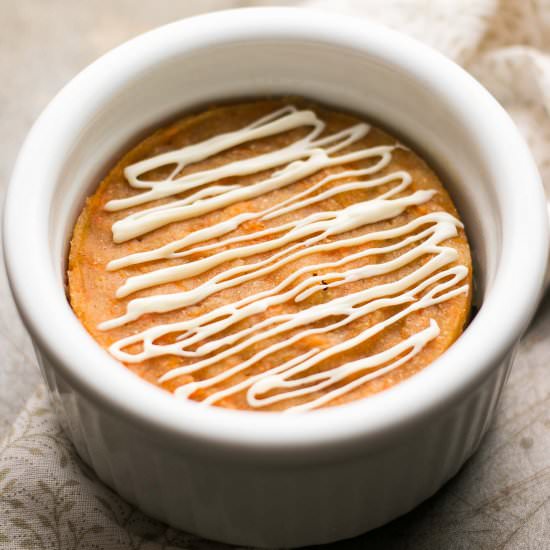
[3,8,548,458]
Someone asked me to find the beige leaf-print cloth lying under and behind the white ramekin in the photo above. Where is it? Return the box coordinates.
[0,0,550,550]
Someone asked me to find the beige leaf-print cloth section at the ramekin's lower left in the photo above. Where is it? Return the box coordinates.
[0,386,250,550]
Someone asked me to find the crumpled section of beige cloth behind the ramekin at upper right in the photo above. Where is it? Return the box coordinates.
[305,0,550,202]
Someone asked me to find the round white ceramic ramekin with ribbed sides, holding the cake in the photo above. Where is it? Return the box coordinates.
[4,8,548,547]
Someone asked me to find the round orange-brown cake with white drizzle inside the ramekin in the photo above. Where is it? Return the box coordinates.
[68,98,472,412]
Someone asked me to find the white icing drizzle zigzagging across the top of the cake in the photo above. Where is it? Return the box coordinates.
[99,106,468,411]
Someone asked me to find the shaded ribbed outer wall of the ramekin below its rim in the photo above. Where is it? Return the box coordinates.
[37,349,513,547]
